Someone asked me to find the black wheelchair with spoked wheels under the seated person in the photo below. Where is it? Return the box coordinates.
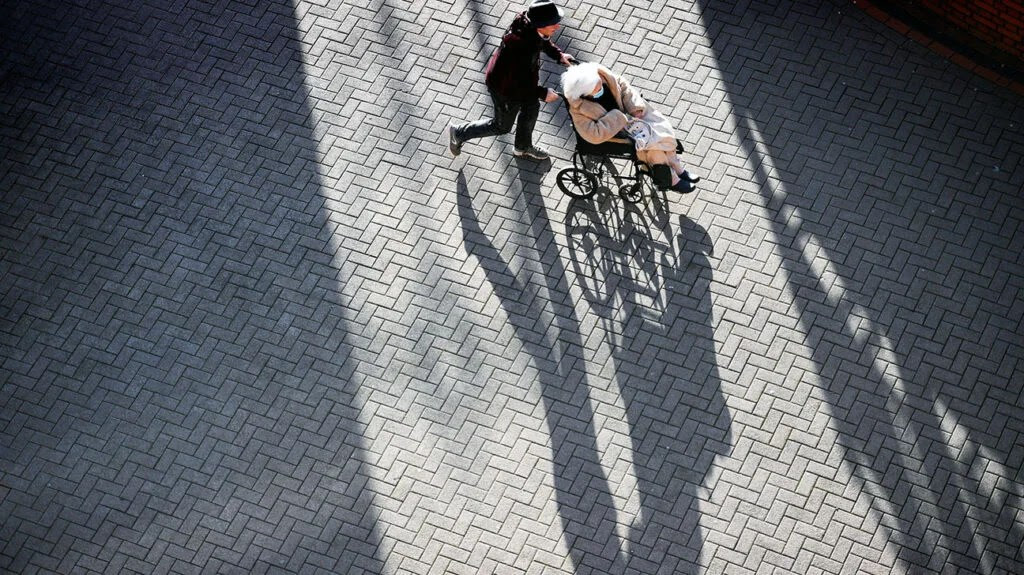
[555,95,700,204]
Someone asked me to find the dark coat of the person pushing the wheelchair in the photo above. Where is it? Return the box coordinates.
[486,12,562,102]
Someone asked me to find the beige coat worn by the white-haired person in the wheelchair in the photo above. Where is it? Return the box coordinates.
[569,64,675,164]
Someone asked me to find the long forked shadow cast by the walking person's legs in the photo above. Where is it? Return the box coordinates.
[457,166,625,574]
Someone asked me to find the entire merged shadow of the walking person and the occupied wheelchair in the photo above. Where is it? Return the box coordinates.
[457,154,730,575]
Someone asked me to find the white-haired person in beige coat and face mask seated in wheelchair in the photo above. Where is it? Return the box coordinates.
[561,62,698,193]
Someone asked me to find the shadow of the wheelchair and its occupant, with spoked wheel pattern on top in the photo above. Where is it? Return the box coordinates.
[565,202,731,573]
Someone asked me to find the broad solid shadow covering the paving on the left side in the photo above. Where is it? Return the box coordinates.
[0,0,383,574]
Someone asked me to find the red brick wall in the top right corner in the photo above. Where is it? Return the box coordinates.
[915,0,1024,59]
